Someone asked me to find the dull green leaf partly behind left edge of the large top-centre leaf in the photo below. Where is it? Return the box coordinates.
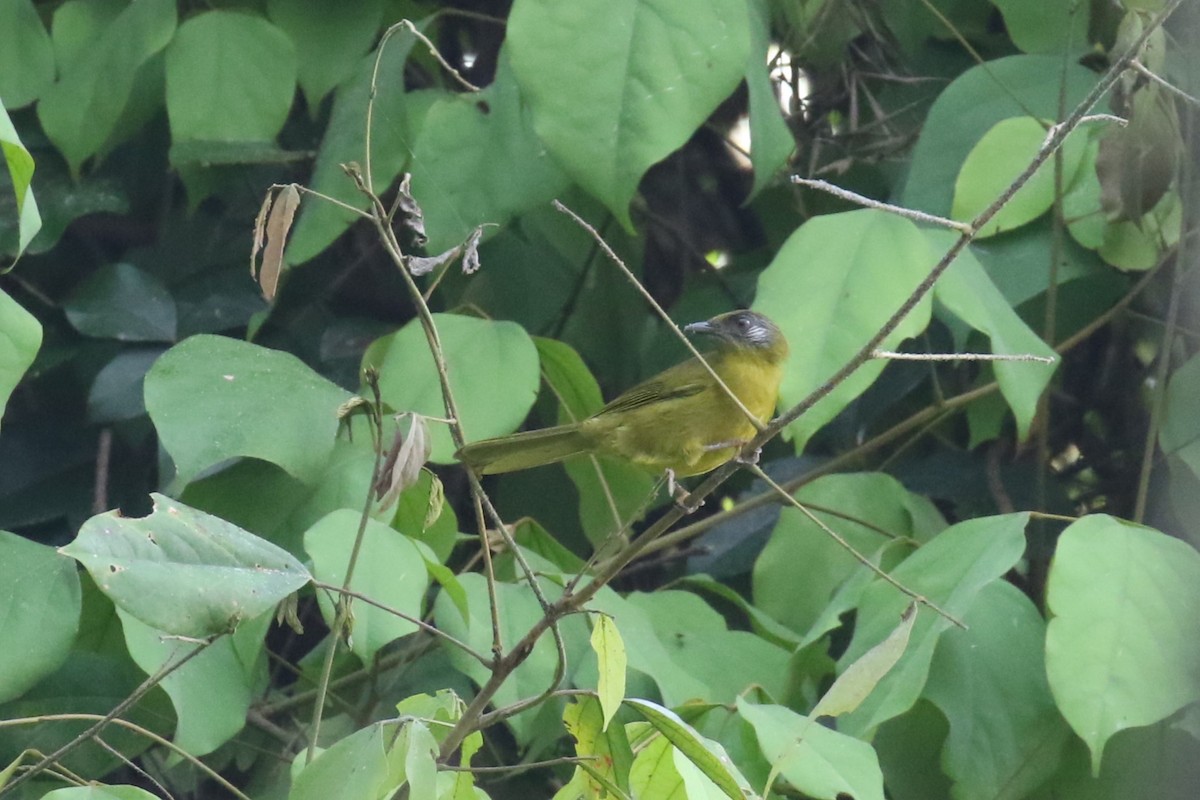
[412,53,568,253]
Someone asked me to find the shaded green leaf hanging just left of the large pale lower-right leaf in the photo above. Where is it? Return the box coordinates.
[925,581,1069,800]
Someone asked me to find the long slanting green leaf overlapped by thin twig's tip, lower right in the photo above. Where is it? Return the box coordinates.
[838,513,1028,735]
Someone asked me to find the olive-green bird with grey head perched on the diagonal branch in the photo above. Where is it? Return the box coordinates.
[457,311,787,477]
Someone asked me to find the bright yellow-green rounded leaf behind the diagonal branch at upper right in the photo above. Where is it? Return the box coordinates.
[950,116,1087,239]
